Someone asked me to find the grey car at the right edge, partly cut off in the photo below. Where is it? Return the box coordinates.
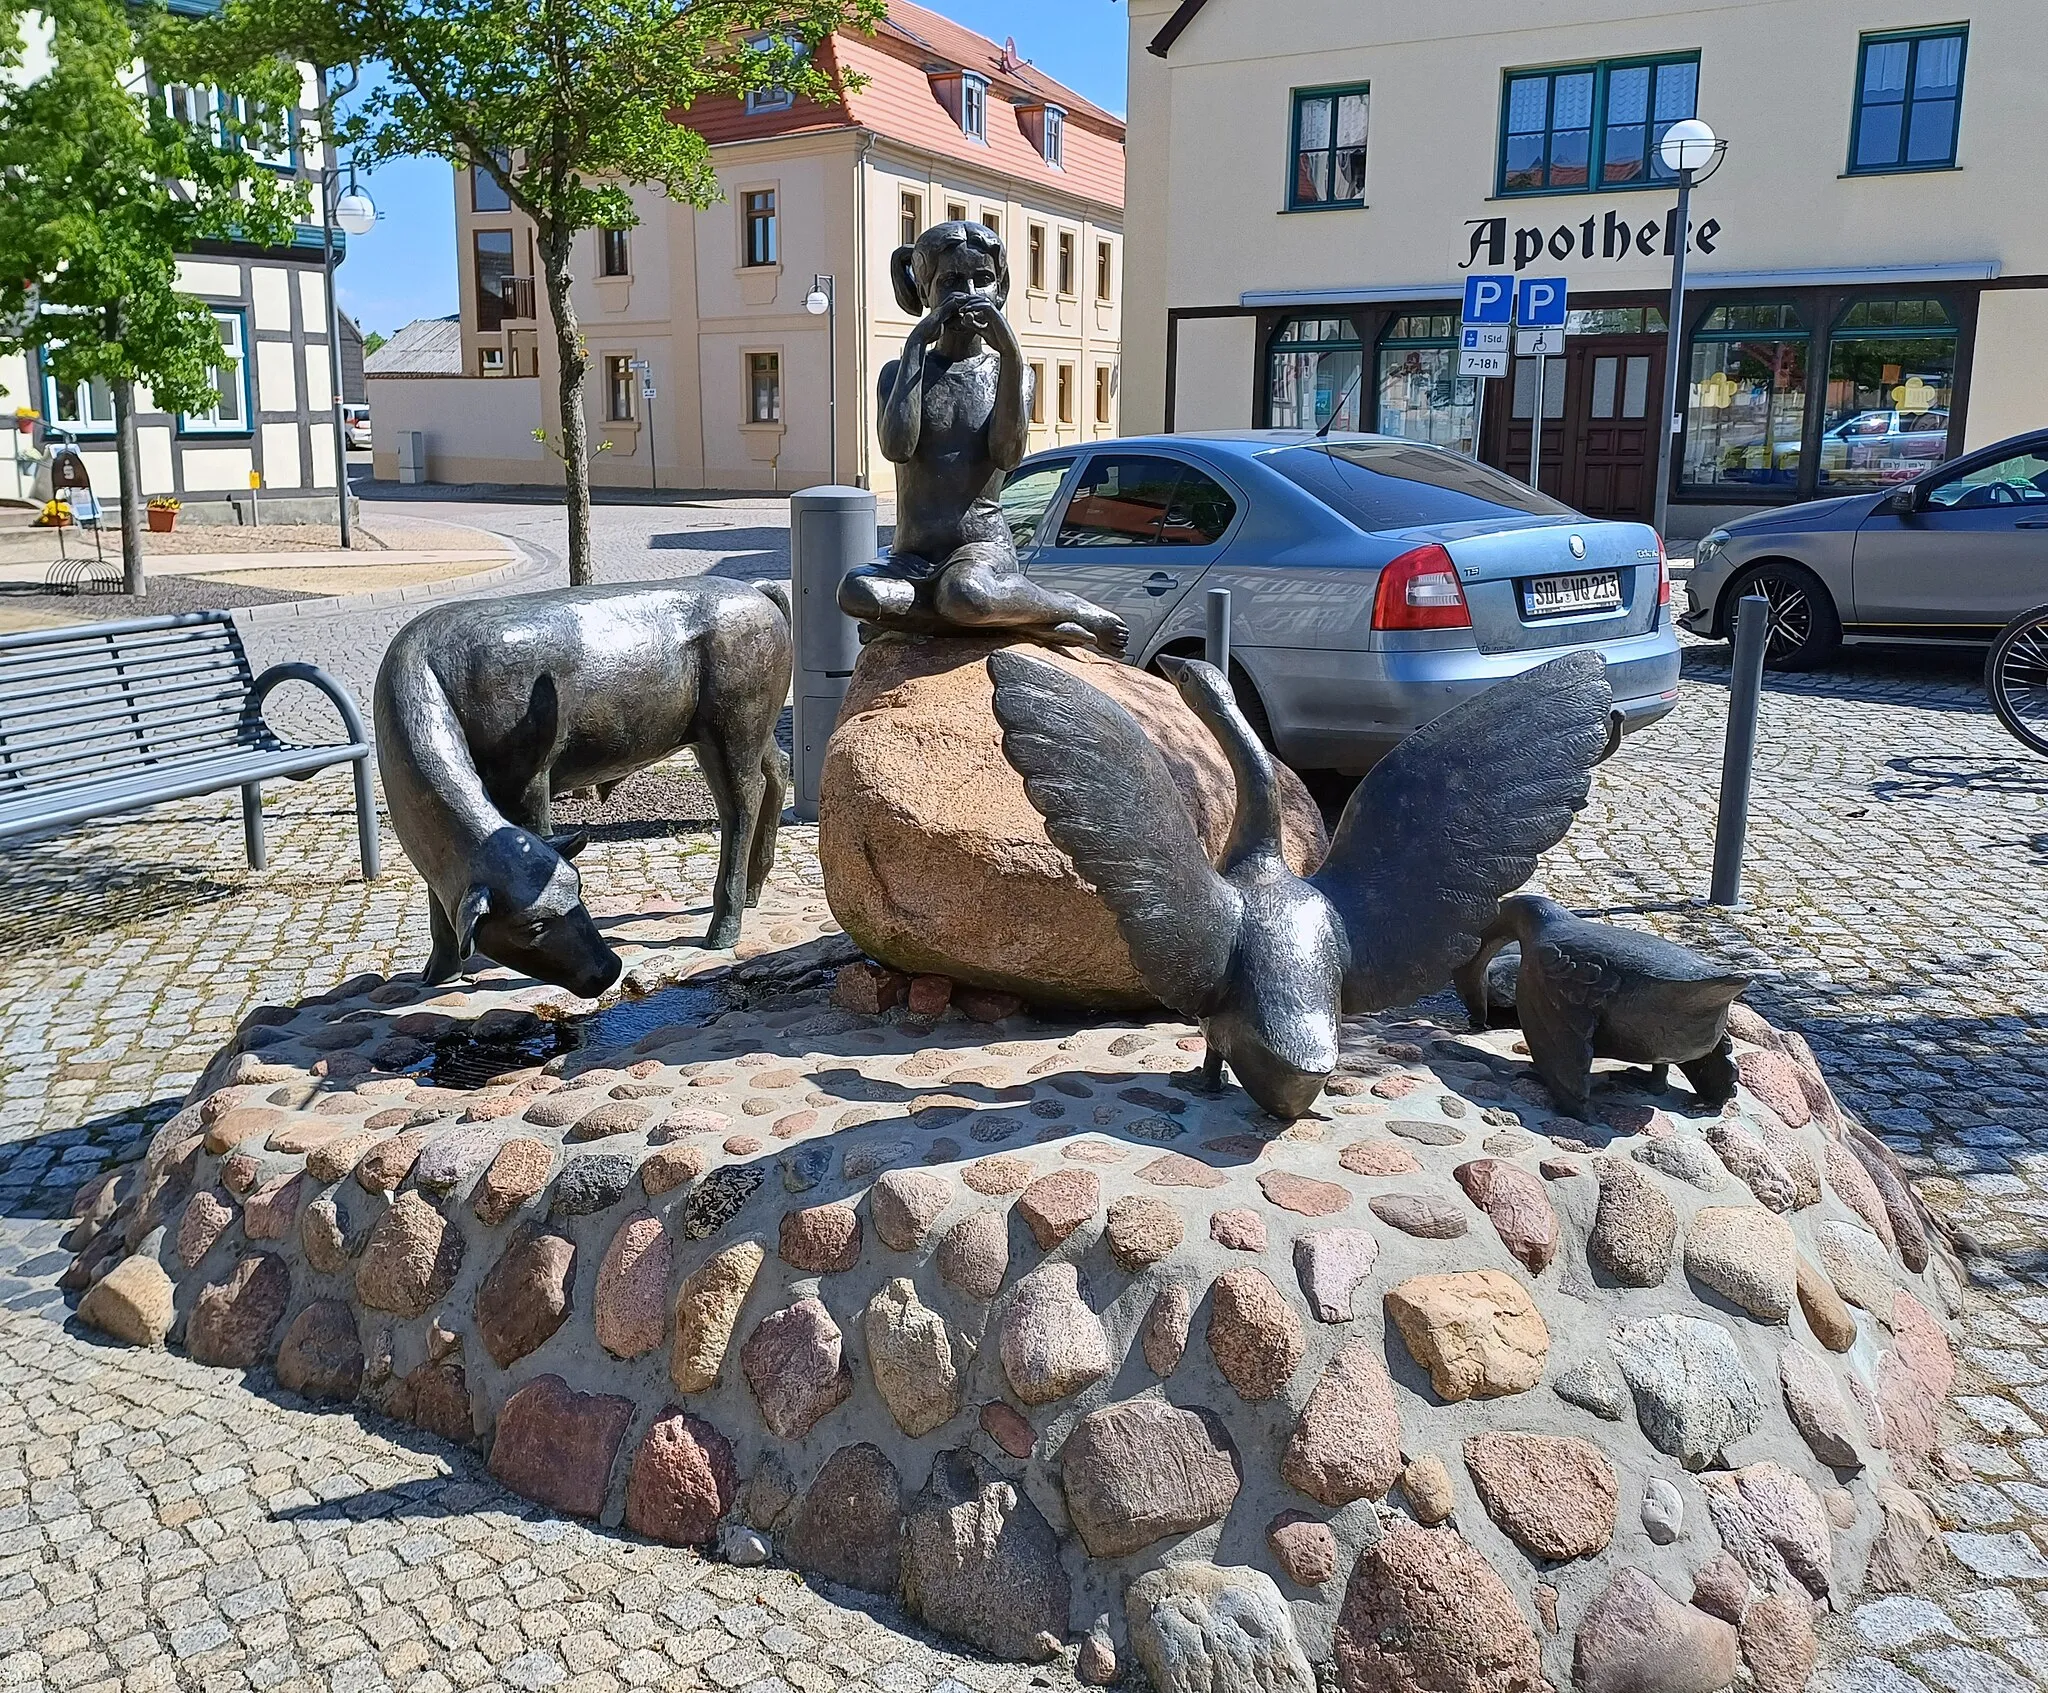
[1681,430,2048,669]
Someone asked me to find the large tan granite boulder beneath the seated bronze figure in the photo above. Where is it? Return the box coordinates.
[817,635,1327,1007]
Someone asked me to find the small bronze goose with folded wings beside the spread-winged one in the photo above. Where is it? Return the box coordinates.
[1456,895,1749,1122]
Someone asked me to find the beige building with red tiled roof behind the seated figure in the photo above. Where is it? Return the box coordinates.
[369,4,1122,491]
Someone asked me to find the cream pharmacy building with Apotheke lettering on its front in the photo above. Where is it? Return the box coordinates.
[1122,0,2048,536]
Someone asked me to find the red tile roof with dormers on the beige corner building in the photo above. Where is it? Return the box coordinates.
[688,0,1124,207]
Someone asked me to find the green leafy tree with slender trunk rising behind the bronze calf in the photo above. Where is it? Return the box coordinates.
[193,0,885,583]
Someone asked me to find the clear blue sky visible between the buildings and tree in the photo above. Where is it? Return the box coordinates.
[336,0,1128,336]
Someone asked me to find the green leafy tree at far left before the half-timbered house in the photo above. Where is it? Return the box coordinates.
[0,0,307,594]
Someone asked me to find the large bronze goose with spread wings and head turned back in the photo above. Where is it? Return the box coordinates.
[987,651,1614,1120]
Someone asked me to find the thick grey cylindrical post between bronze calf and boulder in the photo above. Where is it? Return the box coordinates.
[788,487,877,823]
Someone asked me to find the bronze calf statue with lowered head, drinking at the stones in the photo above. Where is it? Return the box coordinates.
[377,577,791,999]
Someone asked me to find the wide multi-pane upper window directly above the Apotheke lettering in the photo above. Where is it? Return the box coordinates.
[1499,53,1700,194]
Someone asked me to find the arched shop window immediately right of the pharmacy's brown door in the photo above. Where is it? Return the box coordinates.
[1679,301,1806,489]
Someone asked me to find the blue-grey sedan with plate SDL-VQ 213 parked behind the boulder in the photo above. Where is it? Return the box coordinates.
[1001,430,1679,772]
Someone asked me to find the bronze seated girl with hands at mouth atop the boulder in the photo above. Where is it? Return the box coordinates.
[840,223,1128,653]
